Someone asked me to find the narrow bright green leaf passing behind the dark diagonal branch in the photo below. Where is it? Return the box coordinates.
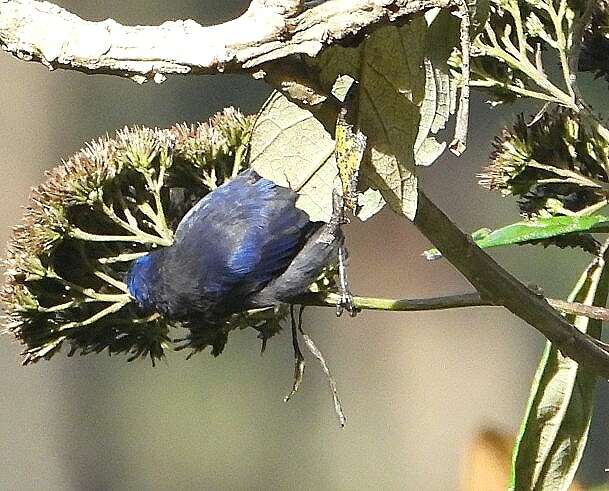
[424,215,609,260]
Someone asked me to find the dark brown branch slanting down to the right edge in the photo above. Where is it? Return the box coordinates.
[414,190,609,379]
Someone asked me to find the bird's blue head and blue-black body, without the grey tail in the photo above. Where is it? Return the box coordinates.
[128,170,315,318]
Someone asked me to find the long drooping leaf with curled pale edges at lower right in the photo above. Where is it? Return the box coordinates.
[511,245,609,491]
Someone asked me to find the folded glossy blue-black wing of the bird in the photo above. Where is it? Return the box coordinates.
[176,170,312,297]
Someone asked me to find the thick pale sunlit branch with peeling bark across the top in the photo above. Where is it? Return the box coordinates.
[0,0,452,83]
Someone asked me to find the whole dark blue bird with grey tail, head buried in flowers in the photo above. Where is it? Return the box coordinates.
[126,169,352,324]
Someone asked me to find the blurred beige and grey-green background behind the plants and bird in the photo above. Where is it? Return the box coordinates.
[0,0,609,490]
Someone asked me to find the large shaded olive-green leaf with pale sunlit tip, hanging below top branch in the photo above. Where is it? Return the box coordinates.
[312,14,458,218]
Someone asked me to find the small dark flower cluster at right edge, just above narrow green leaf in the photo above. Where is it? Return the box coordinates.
[480,109,609,218]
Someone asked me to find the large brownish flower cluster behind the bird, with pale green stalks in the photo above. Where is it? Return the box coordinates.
[1,108,334,364]
